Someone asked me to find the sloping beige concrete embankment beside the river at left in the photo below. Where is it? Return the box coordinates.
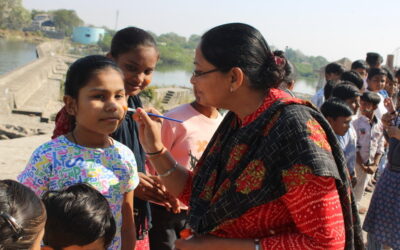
[0,41,67,116]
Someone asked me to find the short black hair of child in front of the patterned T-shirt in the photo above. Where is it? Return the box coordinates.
[42,183,116,250]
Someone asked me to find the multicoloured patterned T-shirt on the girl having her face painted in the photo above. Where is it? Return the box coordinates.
[18,135,139,249]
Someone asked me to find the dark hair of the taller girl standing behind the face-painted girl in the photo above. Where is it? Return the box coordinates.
[110,27,158,58]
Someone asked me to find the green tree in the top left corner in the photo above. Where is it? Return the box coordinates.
[0,0,31,30]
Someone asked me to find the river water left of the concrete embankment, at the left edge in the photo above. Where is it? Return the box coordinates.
[0,39,36,75]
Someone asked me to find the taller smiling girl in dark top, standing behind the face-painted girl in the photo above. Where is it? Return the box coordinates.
[53,27,167,250]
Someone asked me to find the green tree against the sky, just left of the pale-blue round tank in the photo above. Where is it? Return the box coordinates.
[51,9,83,36]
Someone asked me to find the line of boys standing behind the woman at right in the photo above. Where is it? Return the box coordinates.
[312,53,400,249]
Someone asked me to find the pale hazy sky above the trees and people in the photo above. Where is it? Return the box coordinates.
[23,0,400,64]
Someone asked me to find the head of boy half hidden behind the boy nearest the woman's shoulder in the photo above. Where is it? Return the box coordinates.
[332,81,361,114]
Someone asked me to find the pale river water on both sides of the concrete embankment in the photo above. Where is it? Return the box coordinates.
[0,39,317,95]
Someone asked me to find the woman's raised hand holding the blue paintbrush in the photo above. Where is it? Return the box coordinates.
[133,108,164,153]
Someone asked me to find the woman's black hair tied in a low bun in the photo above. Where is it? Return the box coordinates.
[199,23,285,91]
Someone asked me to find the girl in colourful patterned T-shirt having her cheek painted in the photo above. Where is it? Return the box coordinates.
[18,56,139,249]
